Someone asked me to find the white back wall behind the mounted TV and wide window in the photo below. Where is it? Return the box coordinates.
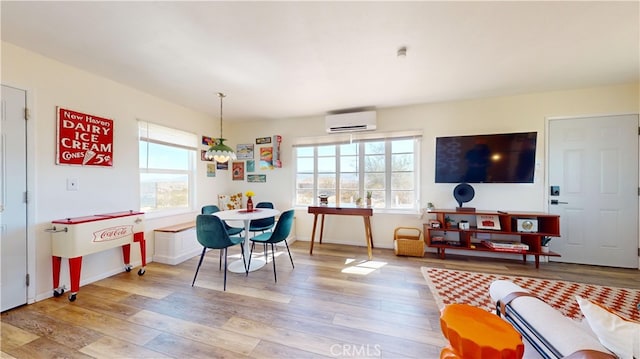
[228,83,640,258]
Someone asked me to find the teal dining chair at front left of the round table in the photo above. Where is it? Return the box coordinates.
[191,214,247,291]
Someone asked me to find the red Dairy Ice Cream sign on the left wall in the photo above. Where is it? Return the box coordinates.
[56,107,113,167]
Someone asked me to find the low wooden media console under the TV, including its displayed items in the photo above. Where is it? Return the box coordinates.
[424,209,560,268]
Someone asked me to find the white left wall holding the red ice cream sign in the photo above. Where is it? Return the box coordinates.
[2,42,228,300]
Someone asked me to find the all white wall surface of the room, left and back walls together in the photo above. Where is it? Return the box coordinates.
[2,42,640,300]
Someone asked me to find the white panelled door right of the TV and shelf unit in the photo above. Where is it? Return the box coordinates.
[549,115,639,268]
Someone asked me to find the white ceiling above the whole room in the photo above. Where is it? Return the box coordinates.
[0,1,640,121]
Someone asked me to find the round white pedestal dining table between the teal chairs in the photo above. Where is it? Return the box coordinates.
[212,208,280,273]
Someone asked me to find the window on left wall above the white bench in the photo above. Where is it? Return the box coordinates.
[138,121,198,214]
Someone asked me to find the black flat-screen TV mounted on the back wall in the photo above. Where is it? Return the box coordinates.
[436,132,537,183]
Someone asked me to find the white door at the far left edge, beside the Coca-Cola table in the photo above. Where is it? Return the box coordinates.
[0,86,27,311]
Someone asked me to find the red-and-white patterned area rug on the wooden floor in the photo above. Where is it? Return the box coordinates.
[421,267,640,322]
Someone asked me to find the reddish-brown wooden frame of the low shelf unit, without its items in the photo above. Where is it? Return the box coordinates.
[423,209,560,268]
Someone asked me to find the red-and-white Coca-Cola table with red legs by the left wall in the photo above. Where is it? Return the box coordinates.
[47,211,147,302]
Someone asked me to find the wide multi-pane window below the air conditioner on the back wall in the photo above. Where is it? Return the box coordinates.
[294,135,421,210]
